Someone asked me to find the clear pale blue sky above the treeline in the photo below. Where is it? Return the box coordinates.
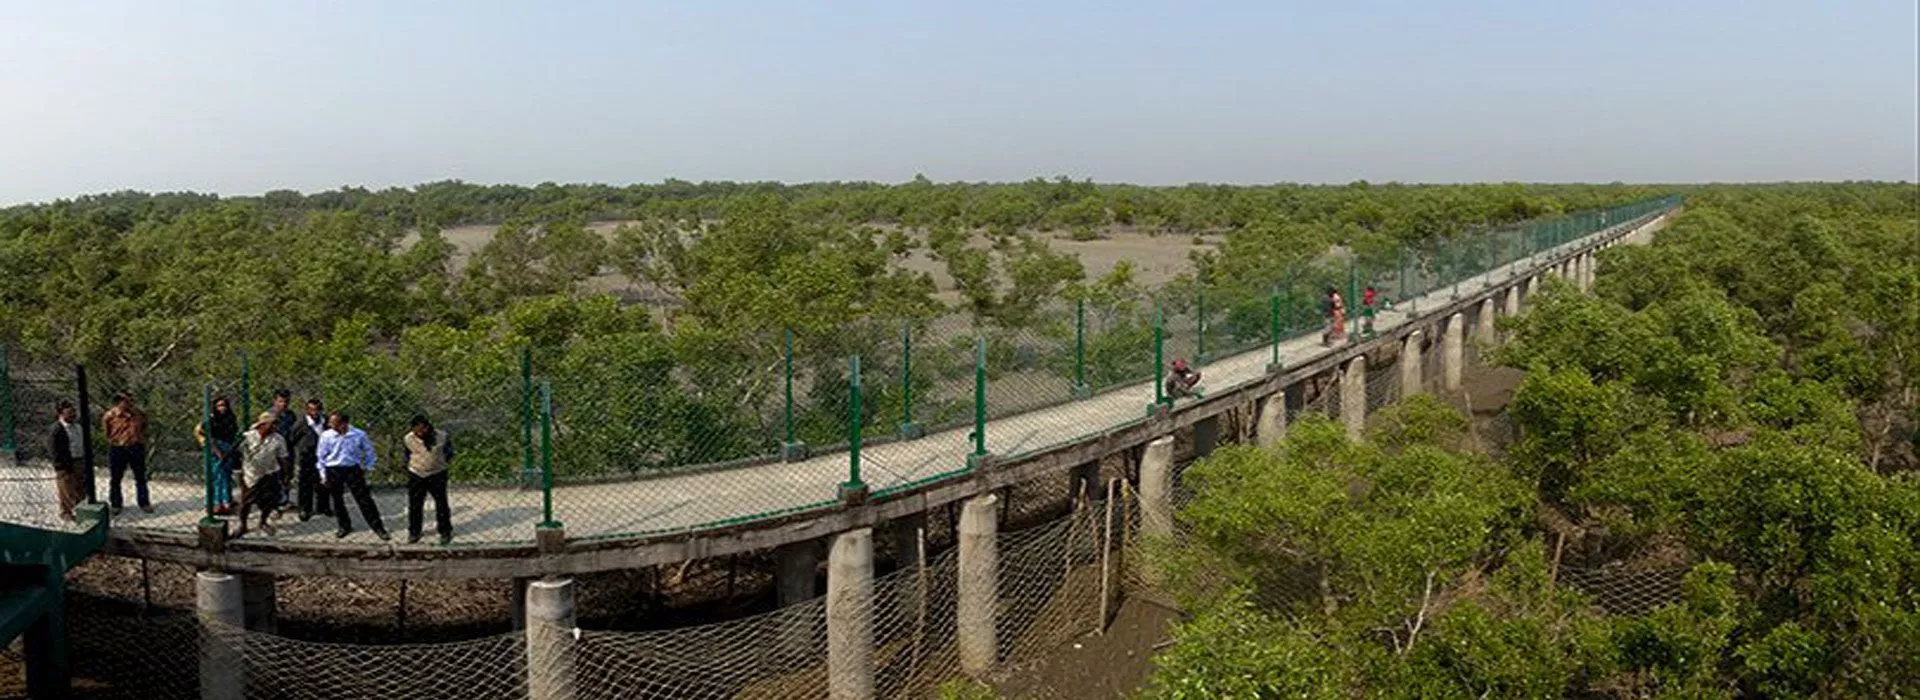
[0,0,1920,203]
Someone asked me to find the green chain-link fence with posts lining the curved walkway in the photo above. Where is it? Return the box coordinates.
[0,198,1676,547]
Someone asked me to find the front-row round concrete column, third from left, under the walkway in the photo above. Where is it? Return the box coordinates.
[828,527,874,700]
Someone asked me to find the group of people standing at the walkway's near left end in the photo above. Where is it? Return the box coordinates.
[48,389,455,545]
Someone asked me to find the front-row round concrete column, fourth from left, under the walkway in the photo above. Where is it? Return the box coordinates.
[954,493,1000,679]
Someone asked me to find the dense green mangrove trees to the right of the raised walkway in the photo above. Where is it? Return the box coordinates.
[1154,184,1920,698]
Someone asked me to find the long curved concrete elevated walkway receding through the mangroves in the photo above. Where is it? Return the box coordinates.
[0,201,1676,579]
